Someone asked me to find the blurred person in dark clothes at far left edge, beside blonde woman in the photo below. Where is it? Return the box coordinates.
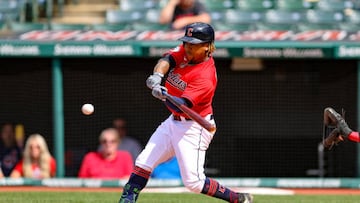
[0,123,22,178]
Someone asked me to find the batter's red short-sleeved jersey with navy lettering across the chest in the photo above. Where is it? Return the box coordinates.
[165,45,217,117]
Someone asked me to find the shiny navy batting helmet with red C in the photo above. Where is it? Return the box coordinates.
[179,22,215,44]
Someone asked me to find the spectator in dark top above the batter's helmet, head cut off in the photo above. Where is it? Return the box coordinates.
[159,0,211,30]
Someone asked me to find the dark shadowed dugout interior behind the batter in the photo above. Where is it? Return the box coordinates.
[0,0,359,182]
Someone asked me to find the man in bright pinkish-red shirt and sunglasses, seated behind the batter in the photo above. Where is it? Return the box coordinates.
[79,128,133,179]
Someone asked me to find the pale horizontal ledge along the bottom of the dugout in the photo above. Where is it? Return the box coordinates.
[0,178,360,189]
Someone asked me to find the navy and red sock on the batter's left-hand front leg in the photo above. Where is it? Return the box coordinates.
[119,166,151,203]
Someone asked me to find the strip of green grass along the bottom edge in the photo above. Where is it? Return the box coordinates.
[0,192,360,203]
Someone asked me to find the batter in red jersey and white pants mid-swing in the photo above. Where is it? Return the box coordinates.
[119,23,252,203]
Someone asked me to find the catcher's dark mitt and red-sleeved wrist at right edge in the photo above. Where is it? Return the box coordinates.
[323,107,360,149]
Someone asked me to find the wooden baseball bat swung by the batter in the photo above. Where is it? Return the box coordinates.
[163,92,216,133]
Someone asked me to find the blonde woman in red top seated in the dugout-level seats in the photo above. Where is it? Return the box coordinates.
[10,134,56,179]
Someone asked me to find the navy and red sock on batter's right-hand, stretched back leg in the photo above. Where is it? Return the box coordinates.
[201,178,239,203]
